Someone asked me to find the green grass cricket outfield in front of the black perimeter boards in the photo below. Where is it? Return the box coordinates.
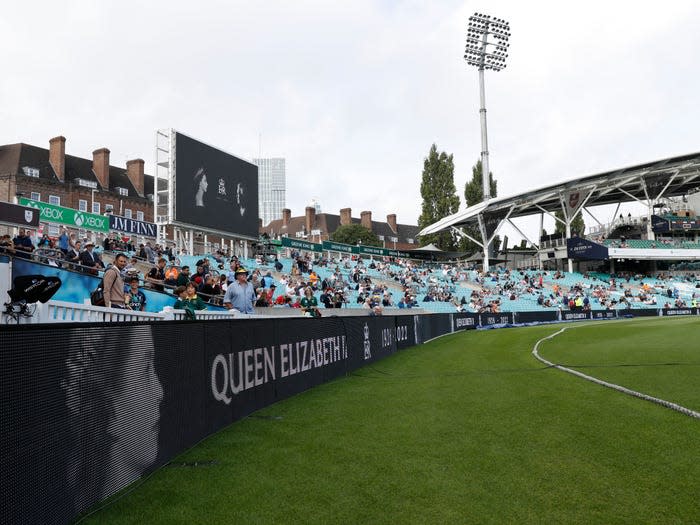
[80,318,700,524]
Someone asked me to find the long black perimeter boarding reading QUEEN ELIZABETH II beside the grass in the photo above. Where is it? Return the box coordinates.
[8,309,680,524]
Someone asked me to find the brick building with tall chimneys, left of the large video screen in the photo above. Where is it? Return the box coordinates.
[0,137,154,235]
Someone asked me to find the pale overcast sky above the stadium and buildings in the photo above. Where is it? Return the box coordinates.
[0,0,700,242]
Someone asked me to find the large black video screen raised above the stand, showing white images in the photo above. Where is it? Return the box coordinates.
[175,133,258,237]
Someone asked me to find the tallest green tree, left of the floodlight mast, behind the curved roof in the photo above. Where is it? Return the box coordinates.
[418,144,459,251]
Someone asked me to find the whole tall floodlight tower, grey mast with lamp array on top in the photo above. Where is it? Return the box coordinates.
[464,13,510,201]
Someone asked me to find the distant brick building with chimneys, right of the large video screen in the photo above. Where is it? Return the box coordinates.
[260,206,420,250]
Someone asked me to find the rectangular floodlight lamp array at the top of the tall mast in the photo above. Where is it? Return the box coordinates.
[464,13,510,71]
